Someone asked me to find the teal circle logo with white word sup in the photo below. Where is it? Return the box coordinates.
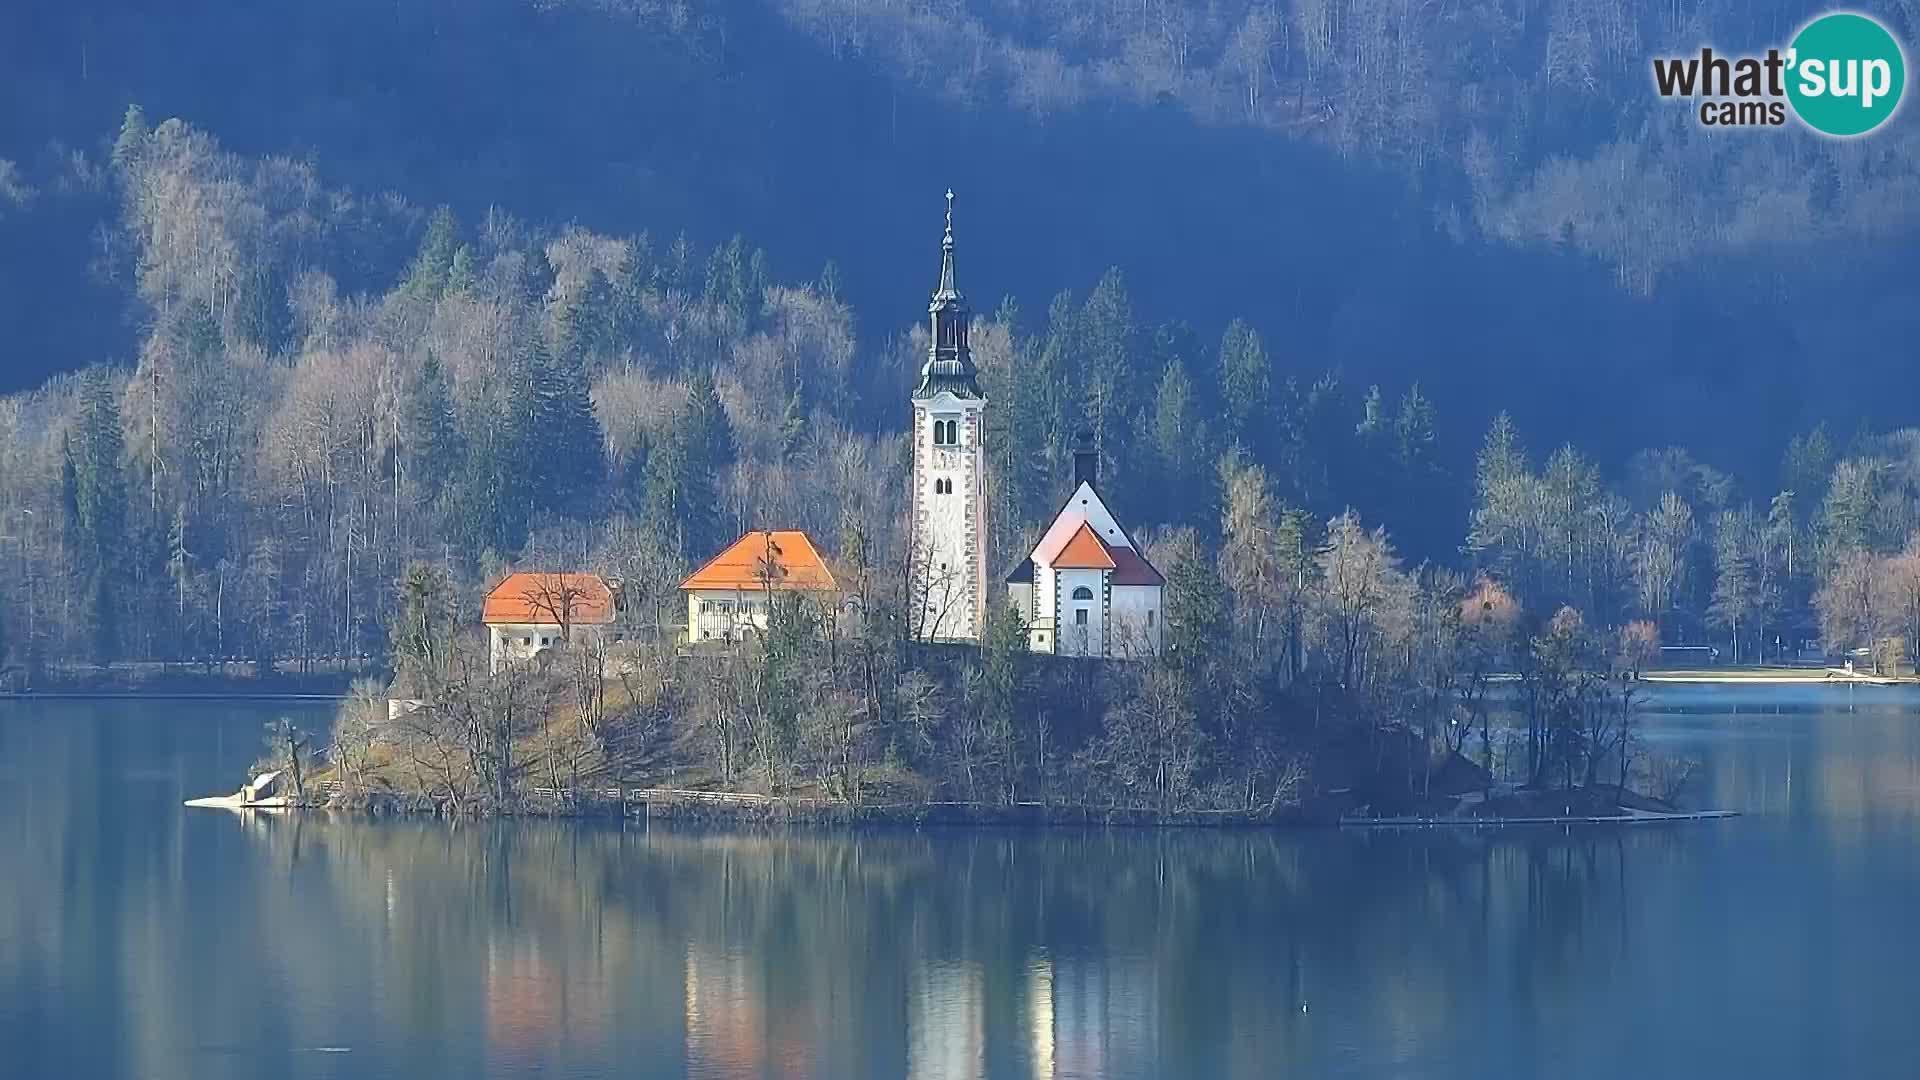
[1788,12,1907,136]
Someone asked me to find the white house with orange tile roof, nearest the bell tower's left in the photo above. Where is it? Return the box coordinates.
[680,528,845,642]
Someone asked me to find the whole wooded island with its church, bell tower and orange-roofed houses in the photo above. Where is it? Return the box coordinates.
[194,201,1743,824]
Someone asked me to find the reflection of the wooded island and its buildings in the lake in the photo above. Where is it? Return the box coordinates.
[198,817,1695,1078]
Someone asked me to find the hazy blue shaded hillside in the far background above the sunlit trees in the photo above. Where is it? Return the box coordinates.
[0,0,1920,473]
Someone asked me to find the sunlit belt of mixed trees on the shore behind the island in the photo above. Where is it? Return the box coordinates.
[0,108,1920,663]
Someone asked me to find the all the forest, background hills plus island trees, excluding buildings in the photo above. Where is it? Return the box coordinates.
[0,0,1920,809]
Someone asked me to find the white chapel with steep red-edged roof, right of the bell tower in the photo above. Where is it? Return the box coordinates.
[1006,436,1167,659]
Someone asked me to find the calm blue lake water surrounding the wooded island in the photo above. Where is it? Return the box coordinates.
[0,688,1920,1080]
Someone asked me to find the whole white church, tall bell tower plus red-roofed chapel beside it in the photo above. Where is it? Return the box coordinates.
[910,192,1165,657]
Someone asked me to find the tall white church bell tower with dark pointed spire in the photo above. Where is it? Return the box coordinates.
[908,190,987,642]
